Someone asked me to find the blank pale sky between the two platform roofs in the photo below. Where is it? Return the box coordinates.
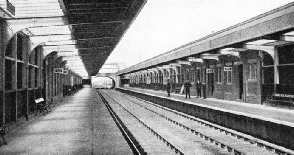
[106,0,292,67]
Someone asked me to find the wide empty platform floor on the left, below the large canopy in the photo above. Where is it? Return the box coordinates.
[0,88,133,155]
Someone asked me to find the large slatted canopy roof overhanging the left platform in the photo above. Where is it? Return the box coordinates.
[5,0,147,76]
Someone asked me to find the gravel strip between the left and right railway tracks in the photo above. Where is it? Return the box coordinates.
[104,90,231,155]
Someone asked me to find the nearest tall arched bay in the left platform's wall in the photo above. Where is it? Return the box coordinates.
[4,33,30,123]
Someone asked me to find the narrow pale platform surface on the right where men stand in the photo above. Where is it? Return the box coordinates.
[122,87,294,124]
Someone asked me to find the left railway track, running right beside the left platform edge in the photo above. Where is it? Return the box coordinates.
[98,91,183,155]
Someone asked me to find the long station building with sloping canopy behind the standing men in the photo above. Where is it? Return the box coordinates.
[117,3,294,106]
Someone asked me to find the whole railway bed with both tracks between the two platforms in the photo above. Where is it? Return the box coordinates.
[98,90,287,155]
